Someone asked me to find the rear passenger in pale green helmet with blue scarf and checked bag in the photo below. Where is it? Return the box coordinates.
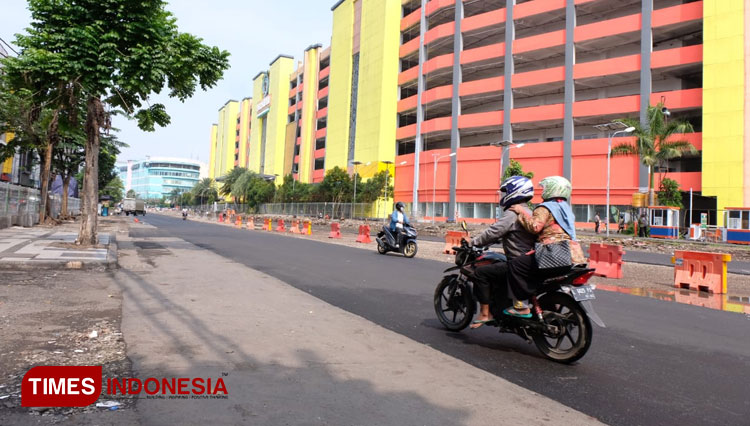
[503,176,586,318]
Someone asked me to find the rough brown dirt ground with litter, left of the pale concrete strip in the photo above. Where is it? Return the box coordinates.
[0,270,137,425]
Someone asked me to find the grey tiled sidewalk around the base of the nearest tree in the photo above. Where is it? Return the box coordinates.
[0,218,118,269]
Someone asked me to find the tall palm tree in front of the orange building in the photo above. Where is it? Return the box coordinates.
[612,102,698,205]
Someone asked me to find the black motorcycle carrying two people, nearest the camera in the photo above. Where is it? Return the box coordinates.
[434,241,605,364]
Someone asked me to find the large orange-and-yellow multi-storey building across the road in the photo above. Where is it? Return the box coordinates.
[207,0,750,223]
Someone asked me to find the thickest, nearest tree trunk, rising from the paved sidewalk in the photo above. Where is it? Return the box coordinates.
[76,96,105,246]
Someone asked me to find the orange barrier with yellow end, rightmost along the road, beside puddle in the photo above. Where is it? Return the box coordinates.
[672,250,732,294]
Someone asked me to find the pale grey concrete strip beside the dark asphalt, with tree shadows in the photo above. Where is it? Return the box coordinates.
[114,224,598,425]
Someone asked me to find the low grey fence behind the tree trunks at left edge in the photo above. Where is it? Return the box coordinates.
[0,182,81,217]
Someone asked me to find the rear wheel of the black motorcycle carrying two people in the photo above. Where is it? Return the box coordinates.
[533,292,592,364]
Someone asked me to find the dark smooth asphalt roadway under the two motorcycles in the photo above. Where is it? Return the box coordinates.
[141,215,750,425]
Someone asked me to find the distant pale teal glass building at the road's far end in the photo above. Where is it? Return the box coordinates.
[117,157,205,200]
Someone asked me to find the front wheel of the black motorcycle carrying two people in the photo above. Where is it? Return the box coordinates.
[434,275,476,331]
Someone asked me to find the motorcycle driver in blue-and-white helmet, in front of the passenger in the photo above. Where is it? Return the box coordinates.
[471,176,536,328]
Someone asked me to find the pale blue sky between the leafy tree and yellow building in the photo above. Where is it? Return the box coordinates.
[0,0,335,163]
